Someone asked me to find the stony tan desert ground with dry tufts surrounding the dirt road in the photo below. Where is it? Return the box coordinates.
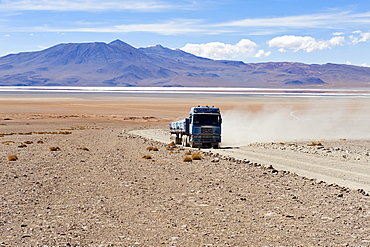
[0,94,370,246]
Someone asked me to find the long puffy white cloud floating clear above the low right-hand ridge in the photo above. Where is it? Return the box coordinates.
[267,35,345,52]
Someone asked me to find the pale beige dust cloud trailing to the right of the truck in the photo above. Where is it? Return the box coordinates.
[222,102,370,146]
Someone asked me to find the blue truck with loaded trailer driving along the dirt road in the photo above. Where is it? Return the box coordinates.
[170,106,222,148]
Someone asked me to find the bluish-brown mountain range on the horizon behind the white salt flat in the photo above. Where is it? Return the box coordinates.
[0,40,370,88]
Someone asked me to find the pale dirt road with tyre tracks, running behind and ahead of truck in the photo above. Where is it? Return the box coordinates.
[131,129,370,192]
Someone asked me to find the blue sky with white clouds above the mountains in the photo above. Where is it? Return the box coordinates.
[0,0,370,66]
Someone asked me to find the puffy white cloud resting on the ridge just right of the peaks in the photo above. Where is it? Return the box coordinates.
[181,39,264,60]
